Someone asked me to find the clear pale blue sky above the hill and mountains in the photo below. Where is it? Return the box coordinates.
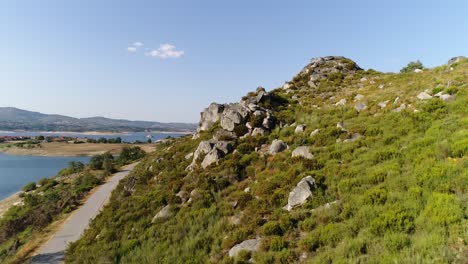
[0,0,468,122]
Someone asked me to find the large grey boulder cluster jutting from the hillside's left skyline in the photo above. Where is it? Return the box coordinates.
[197,87,276,137]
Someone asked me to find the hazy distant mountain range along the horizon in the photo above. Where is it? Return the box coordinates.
[0,107,196,132]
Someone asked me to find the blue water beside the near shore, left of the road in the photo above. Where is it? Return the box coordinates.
[0,153,89,200]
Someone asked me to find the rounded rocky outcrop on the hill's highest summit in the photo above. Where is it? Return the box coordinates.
[283,56,362,89]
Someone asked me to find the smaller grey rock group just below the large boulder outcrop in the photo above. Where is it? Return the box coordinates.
[186,139,233,171]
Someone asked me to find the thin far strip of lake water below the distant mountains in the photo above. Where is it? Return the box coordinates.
[0,131,184,143]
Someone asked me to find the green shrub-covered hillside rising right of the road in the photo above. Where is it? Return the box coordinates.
[67,56,468,263]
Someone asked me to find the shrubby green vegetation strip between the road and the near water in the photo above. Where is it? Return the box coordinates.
[0,147,145,262]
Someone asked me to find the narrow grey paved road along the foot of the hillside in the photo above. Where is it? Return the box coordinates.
[31,164,136,264]
